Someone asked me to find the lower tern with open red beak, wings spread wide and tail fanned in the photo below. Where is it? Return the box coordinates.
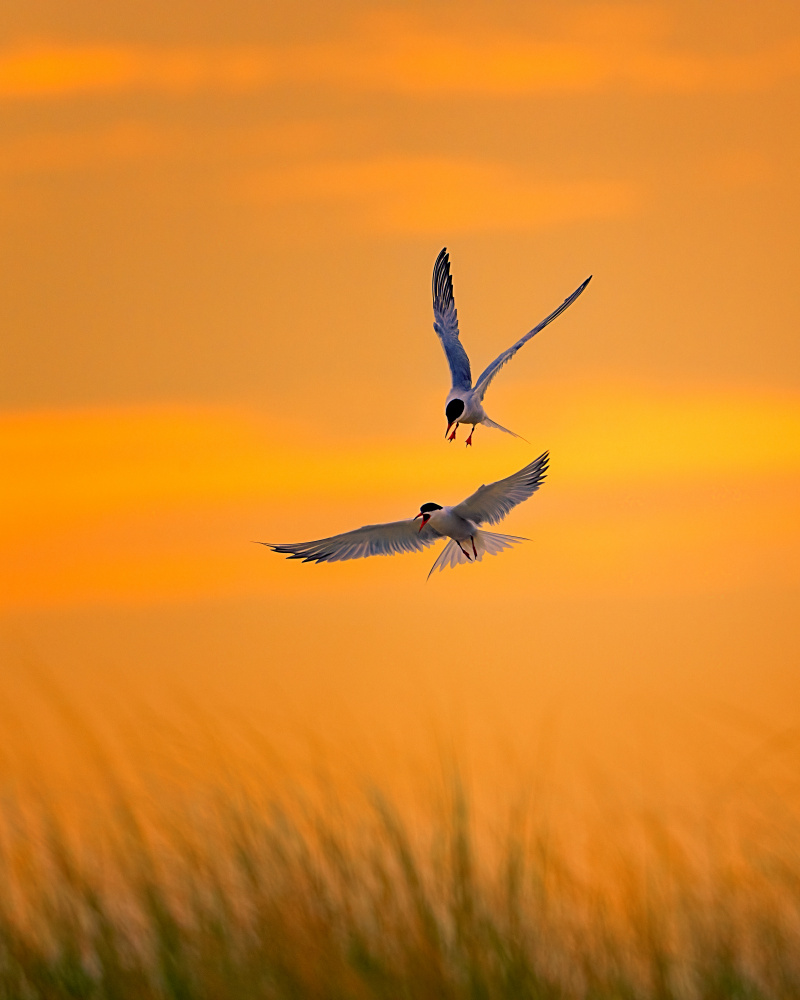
[258,452,549,578]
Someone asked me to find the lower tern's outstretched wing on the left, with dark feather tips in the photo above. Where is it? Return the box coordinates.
[258,520,441,562]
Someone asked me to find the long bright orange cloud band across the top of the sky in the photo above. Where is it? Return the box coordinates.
[0,12,800,100]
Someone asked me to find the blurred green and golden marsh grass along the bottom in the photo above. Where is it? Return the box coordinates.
[0,692,800,1000]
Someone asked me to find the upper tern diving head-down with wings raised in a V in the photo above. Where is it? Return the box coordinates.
[433,247,592,445]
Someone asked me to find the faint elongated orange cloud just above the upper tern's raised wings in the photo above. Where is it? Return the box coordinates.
[235,157,639,234]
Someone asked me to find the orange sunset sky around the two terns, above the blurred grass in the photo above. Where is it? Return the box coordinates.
[0,0,800,804]
